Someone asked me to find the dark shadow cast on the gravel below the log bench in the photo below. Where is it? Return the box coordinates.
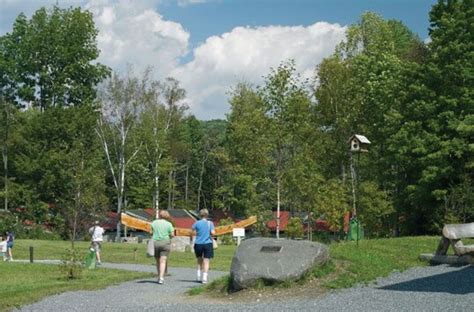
[379,266,474,295]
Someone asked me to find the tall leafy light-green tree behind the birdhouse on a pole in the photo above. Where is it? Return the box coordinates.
[315,12,426,236]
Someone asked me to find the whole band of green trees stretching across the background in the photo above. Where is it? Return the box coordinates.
[0,0,474,241]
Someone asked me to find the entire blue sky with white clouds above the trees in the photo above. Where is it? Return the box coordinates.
[0,0,436,120]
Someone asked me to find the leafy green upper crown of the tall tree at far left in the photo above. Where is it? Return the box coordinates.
[0,6,109,111]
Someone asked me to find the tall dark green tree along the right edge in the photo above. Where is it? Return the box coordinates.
[398,0,474,232]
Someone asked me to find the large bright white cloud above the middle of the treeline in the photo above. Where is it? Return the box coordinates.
[172,22,346,119]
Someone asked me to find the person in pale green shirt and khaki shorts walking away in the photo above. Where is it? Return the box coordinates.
[151,210,174,284]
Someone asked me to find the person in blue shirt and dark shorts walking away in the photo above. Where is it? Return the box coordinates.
[192,209,216,284]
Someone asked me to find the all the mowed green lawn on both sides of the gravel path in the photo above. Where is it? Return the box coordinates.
[0,236,439,310]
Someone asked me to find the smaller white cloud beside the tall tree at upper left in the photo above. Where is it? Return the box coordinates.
[84,0,190,77]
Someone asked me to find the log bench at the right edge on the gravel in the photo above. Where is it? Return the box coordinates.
[420,223,474,264]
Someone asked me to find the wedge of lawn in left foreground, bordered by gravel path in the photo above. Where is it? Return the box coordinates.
[0,261,153,311]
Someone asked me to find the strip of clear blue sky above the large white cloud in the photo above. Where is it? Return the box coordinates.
[157,0,436,53]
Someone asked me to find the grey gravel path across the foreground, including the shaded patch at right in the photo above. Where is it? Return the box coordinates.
[15,264,474,312]
